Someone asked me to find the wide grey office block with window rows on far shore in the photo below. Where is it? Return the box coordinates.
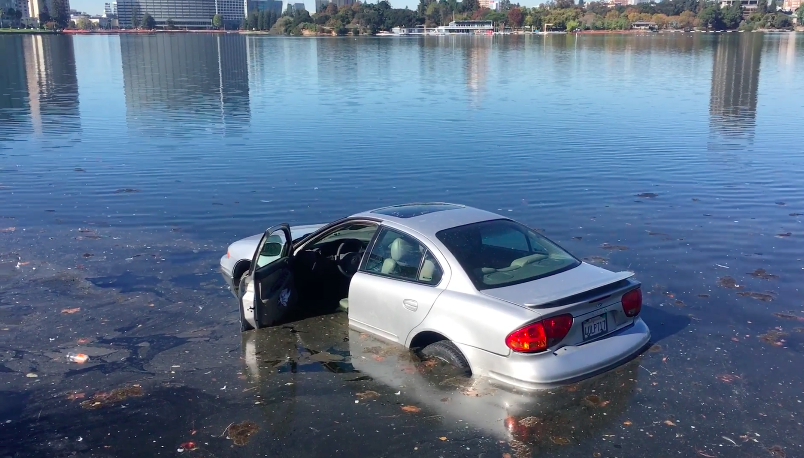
[117,0,217,29]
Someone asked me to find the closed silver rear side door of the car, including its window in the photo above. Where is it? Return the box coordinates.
[349,228,443,344]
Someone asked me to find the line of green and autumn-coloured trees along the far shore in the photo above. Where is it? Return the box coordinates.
[241,0,804,35]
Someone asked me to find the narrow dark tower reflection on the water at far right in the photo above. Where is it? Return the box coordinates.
[709,34,762,139]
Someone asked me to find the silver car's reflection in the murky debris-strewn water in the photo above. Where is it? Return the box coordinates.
[242,313,639,455]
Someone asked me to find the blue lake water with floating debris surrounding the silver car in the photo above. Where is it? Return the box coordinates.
[0,33,804,457]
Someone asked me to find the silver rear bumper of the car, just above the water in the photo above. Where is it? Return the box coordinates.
[458,318,650,389]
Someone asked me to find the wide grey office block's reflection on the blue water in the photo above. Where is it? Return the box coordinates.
[120,34,251,134]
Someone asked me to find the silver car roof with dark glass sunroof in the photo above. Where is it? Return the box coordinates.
[352,202,507,237]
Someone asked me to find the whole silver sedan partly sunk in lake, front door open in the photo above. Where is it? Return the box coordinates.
[221,203,650,389]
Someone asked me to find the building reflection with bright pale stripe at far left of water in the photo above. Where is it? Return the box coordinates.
[0,35,81,134]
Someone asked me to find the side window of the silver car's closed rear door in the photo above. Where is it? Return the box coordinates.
[361,228,443,285]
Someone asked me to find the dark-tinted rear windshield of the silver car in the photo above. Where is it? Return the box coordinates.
[436,220,580,289]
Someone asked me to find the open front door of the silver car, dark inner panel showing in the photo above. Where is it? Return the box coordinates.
[240,223,298,331]
